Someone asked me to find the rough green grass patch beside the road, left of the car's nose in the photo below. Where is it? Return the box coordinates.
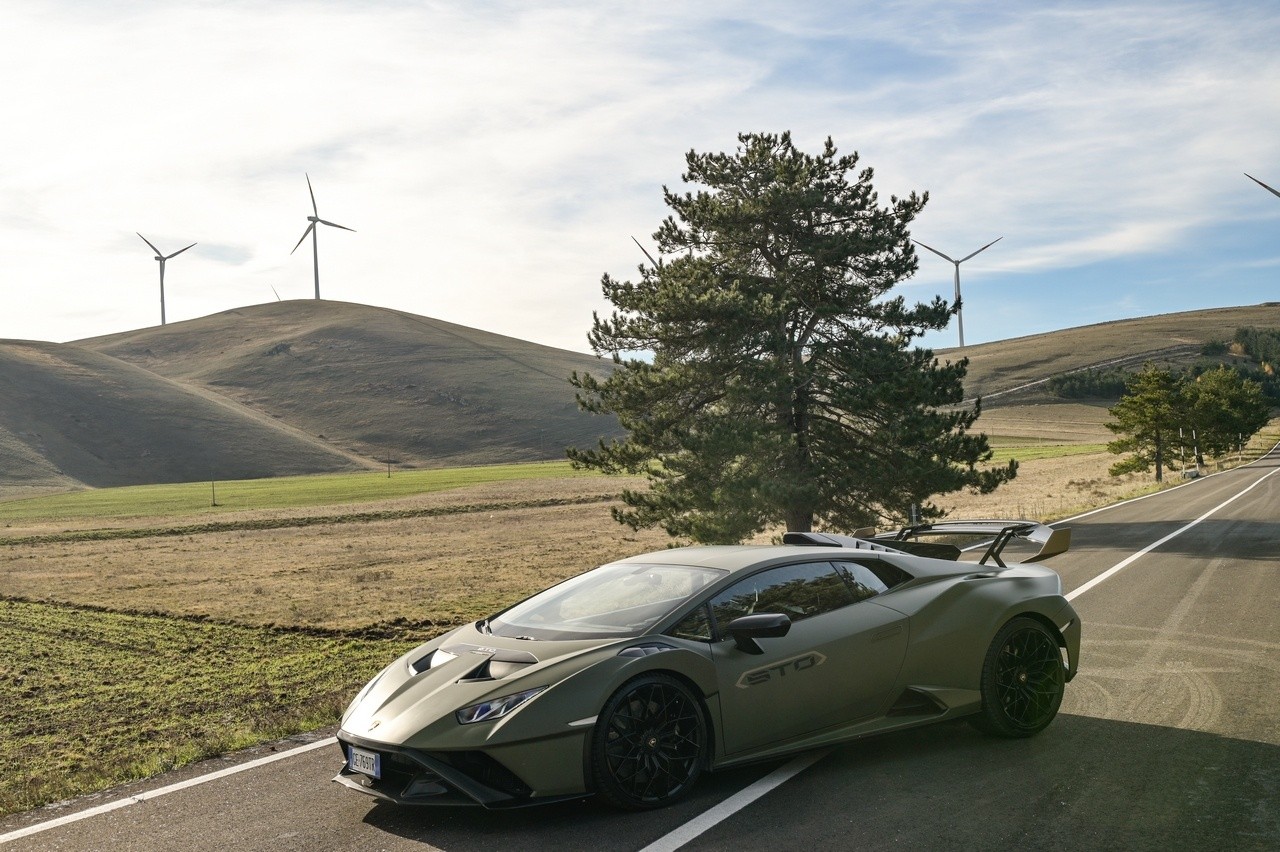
[0,599,410,814]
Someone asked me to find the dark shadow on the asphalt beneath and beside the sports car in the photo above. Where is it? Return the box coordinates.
[353,714,1280,852]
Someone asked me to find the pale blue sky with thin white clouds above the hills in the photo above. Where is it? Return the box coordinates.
[0,0,1280,352]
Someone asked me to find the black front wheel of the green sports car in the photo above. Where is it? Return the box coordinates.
[591,673,710,811]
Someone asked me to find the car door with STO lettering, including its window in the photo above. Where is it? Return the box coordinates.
[710,562,908,755]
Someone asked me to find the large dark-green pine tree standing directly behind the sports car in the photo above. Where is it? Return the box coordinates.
[570,133,1015,542]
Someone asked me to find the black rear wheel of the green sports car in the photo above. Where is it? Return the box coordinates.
[970,618,1066,737]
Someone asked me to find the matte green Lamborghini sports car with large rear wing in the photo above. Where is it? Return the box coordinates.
[334,521,1080,810]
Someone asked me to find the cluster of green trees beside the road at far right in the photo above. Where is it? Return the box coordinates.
[1107,365,1271,482]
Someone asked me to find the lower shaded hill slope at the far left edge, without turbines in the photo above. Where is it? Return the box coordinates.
[0,340,366,496]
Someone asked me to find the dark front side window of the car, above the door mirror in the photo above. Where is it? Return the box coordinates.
[712,562,855,636]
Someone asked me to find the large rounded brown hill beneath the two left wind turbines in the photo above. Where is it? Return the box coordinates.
[79,299,617,467]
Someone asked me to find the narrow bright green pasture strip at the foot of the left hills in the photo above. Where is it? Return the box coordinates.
[0,462,599,523]
